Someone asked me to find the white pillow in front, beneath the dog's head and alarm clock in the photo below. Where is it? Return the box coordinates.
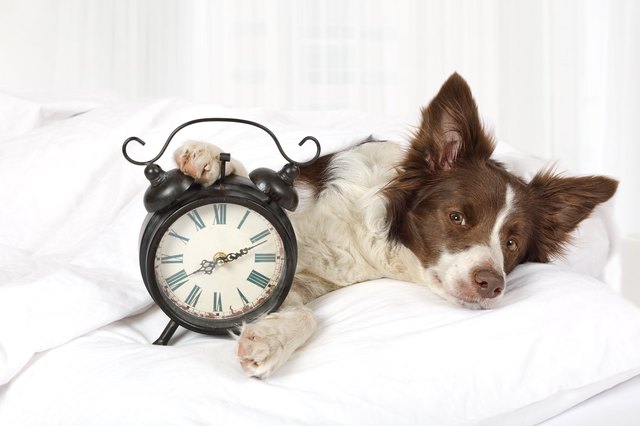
[0,265,640,425]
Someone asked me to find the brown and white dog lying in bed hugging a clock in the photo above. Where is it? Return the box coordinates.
[174,73,618,378]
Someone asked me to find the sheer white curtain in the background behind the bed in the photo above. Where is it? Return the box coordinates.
[0,0,640,280]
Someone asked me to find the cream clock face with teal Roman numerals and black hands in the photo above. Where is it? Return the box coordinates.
[154,203,286,321]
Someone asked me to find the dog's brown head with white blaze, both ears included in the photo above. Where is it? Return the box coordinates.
[385,74,617,308]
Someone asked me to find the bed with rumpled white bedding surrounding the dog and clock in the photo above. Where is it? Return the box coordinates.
[0,93,640,426]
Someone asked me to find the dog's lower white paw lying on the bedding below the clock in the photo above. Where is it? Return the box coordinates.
[237,308,316,379]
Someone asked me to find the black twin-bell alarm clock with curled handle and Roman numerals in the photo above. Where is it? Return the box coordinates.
[122,118,320,345]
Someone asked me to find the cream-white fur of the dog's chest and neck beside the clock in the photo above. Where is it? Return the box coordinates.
[290,142,422,287]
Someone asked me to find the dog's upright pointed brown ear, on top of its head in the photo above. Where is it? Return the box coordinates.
[410,73,494,172]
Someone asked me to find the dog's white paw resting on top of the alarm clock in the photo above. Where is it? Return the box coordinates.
[173,141,222,186]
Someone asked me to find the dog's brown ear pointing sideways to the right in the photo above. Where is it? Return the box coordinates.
[525,170,618,262]
